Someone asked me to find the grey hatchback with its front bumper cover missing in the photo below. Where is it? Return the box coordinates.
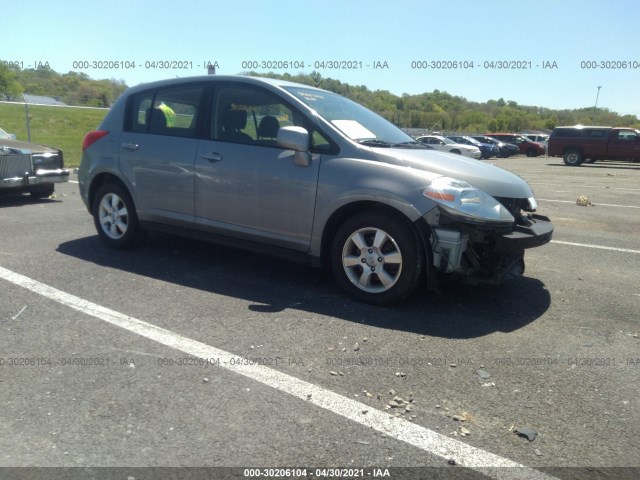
[78,76,553,304]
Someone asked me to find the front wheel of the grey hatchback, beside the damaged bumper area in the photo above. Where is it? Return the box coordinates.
[331,211,424,305]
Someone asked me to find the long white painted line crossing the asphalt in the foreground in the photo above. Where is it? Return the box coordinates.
[0,267,554,480]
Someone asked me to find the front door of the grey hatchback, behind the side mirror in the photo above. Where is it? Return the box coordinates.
[195,83,320,251]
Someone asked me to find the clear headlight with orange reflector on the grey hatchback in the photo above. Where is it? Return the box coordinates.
[422,177,515,223]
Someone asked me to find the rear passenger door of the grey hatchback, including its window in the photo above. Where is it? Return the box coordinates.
[118,84,205,227]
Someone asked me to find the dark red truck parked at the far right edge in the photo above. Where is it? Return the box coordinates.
[548,125,640,167]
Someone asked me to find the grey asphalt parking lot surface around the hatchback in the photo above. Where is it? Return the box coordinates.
[0,157,640,479]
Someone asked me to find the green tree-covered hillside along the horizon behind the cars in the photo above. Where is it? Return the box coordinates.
[0,61,640,132]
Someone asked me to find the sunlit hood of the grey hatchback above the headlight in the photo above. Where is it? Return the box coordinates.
[371,148,533,198]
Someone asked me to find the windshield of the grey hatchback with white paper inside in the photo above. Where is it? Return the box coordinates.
[285,87,415,145]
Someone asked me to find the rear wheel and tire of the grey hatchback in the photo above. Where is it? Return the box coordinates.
[93,183,141,249]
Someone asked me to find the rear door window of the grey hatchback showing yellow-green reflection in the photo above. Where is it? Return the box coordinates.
[125,85,204,137]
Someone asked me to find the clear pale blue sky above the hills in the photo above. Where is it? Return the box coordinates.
[5,0,640,117]
